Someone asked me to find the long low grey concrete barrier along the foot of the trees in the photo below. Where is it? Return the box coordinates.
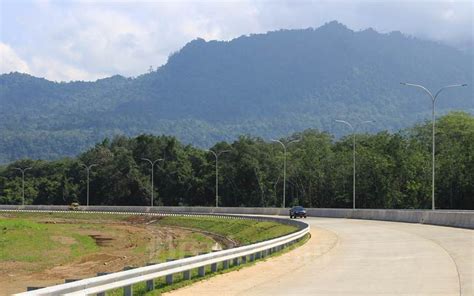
[0,205,474,229]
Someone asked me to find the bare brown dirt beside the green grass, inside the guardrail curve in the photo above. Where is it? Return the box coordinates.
[0,216,226,295]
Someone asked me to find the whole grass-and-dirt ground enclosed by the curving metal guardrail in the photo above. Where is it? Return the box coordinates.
[0,213,293,295]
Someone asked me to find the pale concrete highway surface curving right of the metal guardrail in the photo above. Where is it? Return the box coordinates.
[170,218,474,296]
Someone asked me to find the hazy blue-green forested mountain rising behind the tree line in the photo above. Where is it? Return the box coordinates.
[0,22,474,163]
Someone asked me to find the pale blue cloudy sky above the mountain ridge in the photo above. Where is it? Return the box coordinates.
[0,0,474,81]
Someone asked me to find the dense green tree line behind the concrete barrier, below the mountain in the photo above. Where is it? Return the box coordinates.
[0,112,474,210]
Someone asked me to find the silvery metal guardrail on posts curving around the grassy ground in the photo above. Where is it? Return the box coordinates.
[5,209,310,296]
